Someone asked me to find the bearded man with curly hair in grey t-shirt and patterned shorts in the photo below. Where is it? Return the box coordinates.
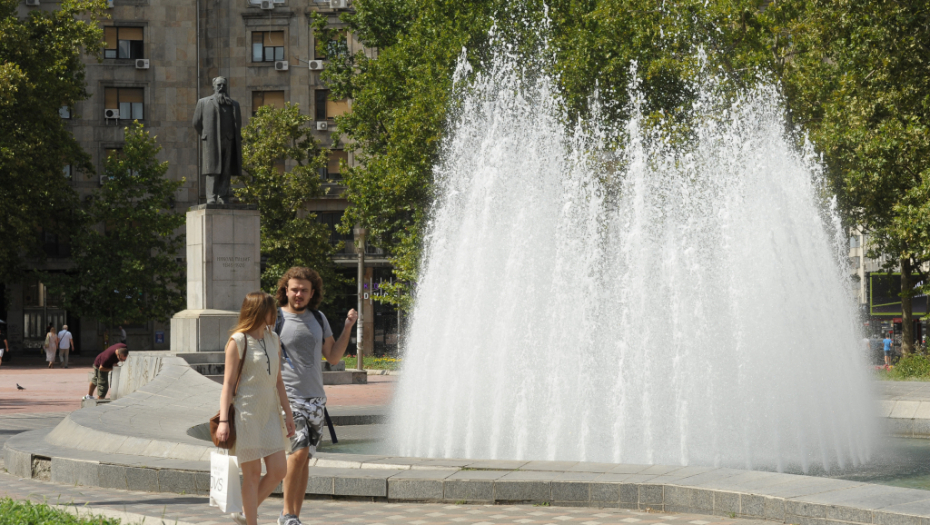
[275,267,358,525]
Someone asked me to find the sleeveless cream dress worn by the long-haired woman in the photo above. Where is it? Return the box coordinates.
[229,330,287,464]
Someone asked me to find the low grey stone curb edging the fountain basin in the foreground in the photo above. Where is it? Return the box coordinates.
[9,430,930,525]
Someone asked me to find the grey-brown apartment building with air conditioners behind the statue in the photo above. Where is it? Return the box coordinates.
[4,0,397,355]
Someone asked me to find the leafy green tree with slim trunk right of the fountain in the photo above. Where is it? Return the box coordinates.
[781,0,930,354]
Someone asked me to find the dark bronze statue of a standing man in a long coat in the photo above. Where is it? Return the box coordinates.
[194,77,242,204]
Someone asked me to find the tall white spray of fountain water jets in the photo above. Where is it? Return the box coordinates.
[389,36,877,472]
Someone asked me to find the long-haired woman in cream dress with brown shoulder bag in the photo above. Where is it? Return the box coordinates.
[216,292,294,525]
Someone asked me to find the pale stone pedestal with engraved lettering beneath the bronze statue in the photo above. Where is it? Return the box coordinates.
[171,204,261,353]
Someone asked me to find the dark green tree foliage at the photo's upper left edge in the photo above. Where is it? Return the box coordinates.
[0,0,105,282]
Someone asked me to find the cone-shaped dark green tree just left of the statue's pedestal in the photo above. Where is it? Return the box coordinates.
[45,122,186,344]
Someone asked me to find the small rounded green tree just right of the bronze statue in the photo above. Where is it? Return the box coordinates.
[235,103,343,301]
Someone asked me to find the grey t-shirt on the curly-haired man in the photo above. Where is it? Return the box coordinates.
[281,310,333,397]
